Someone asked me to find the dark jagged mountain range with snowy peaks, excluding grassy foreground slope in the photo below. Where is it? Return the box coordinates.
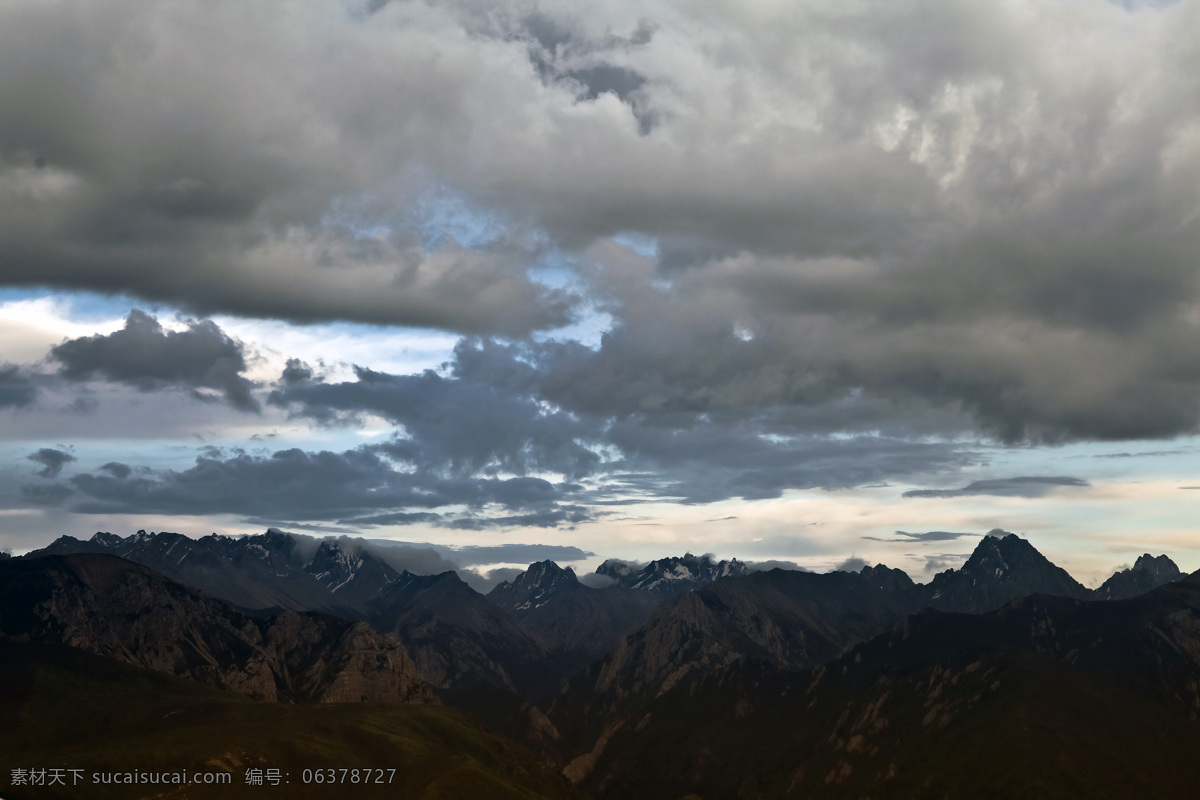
[0,530,1200,798]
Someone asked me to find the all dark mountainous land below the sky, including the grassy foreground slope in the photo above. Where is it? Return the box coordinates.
[0,529,1200,800]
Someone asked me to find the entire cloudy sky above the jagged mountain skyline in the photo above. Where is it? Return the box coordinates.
[0,0,1200,585]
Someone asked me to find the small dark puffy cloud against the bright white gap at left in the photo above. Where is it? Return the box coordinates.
[50,309,259,411]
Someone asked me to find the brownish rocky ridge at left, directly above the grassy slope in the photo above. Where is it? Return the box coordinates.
[0,554,433,702]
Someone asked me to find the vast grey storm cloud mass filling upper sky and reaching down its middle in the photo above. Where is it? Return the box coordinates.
[0,0,1200,515]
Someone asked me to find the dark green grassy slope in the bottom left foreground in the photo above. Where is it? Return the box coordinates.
[0,645,576,800]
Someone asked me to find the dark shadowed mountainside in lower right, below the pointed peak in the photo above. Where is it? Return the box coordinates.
[580,576,1200,800]
